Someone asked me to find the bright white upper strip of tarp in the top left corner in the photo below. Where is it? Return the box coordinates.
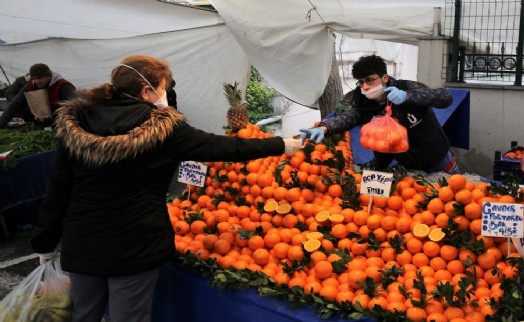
[0,0,223,44]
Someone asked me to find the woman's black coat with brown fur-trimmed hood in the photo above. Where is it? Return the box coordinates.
[31,99,284,276]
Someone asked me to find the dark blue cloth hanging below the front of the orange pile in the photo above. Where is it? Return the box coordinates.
[152,263,376,322]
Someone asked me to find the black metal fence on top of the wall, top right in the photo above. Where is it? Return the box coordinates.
[443,0,524,86]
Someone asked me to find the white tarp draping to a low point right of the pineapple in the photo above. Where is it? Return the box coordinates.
[211,0,445,105]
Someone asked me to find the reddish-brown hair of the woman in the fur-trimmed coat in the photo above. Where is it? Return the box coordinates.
[87,55,172,101]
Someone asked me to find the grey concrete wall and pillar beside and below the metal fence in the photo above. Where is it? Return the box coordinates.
[417,36,524,179]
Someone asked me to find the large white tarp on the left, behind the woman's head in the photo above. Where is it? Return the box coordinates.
[0,0,250,133]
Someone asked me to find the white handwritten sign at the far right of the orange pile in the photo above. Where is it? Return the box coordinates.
[481,202,524,237]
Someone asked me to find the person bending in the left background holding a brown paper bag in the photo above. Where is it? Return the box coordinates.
[0,64,75,128]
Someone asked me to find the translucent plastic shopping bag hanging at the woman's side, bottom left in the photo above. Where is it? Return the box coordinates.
[0,260,73,322]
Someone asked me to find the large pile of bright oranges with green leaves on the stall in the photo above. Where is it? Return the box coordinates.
[167,125,519,322]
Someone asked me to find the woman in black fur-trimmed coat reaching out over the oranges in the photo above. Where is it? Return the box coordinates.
[31,55,302,322]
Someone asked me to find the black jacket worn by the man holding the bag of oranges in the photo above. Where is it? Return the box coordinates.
[320,77,453,170]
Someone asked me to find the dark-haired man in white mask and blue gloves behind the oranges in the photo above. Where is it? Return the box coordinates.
[300,55,459,173]
